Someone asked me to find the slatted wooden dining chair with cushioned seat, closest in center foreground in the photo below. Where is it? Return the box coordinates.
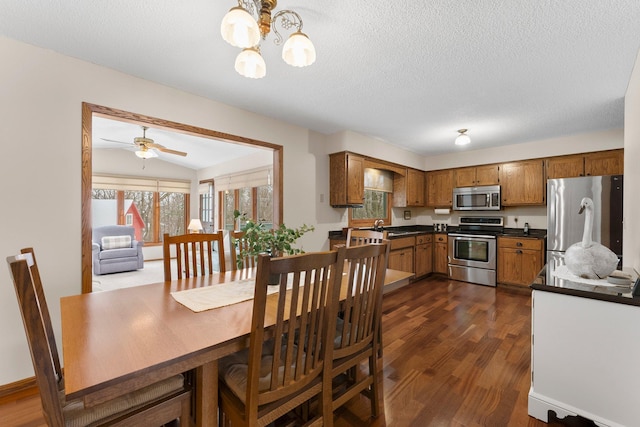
[219,251,344,427]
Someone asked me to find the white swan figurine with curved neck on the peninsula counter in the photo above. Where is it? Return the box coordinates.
[564,197,618,279]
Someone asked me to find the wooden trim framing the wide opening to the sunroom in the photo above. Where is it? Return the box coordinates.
[81,102,284,293]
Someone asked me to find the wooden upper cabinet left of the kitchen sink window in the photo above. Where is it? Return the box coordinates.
[329,151,364,207]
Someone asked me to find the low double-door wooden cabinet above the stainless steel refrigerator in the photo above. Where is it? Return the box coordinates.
[547,150,624,179]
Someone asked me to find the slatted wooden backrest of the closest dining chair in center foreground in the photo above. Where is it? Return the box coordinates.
[246,251,344,412]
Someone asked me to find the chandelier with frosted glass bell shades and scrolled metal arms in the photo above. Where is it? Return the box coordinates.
[220,0,316,79]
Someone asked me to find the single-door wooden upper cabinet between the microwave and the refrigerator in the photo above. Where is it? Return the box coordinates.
[500,160,546,206]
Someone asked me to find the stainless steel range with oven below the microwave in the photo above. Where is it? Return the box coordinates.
[449,216,504,286]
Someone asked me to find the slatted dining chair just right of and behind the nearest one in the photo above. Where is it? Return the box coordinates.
[331,240,391,417]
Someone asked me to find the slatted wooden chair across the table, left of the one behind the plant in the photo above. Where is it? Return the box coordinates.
[162,230,226,282]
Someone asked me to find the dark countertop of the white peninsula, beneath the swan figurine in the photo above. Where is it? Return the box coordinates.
[530,260,640,307]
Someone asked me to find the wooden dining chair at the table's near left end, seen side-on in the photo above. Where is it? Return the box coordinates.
[7,248,191,427]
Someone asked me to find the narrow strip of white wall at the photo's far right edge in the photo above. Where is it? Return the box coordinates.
[622,52,640,272]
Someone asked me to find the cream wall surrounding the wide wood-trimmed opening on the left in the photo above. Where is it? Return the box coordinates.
[0,37,638,385]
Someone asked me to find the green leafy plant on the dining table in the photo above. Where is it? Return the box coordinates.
[233,209,315,266]
